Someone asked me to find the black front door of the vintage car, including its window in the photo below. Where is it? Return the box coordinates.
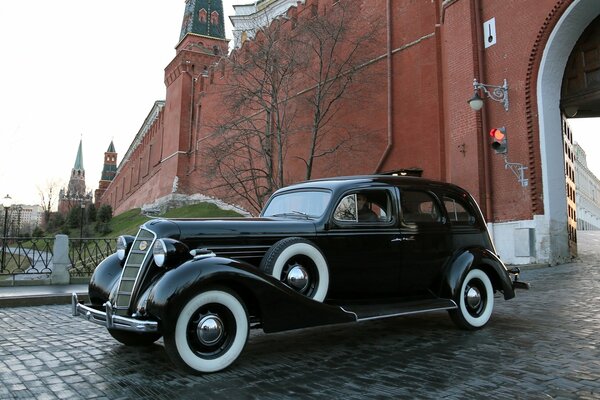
[318,188,400,299]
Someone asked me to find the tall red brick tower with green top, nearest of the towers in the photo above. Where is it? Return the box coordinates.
[153,0,229,198]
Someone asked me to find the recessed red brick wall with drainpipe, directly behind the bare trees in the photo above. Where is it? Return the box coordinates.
[173,0,443,214]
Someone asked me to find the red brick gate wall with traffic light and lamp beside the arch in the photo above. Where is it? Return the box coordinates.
[441,0,570,221]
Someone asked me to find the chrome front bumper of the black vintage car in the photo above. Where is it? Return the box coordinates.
[71,293,158,333]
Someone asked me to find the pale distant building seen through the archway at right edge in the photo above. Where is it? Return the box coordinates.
[573,143,600,231]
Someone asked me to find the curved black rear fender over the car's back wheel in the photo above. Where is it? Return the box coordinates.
[440,247,515,300]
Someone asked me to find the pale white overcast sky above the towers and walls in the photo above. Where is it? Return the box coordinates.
[0,0,600,204]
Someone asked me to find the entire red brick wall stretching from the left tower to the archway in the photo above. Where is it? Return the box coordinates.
[103,0,571,221]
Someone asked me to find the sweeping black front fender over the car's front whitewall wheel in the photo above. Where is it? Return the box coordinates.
[146,257,356,334]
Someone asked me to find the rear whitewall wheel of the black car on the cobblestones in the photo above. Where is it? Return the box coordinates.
[449,269,494,330]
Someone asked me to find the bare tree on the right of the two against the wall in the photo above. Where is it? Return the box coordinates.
[293,1,384,179]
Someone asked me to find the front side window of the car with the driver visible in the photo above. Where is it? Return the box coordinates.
[333,190,392,224]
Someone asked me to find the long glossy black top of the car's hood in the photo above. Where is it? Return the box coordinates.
[143,218,316,240]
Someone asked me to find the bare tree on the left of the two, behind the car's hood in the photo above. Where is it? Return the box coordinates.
[206,21,298,212]
